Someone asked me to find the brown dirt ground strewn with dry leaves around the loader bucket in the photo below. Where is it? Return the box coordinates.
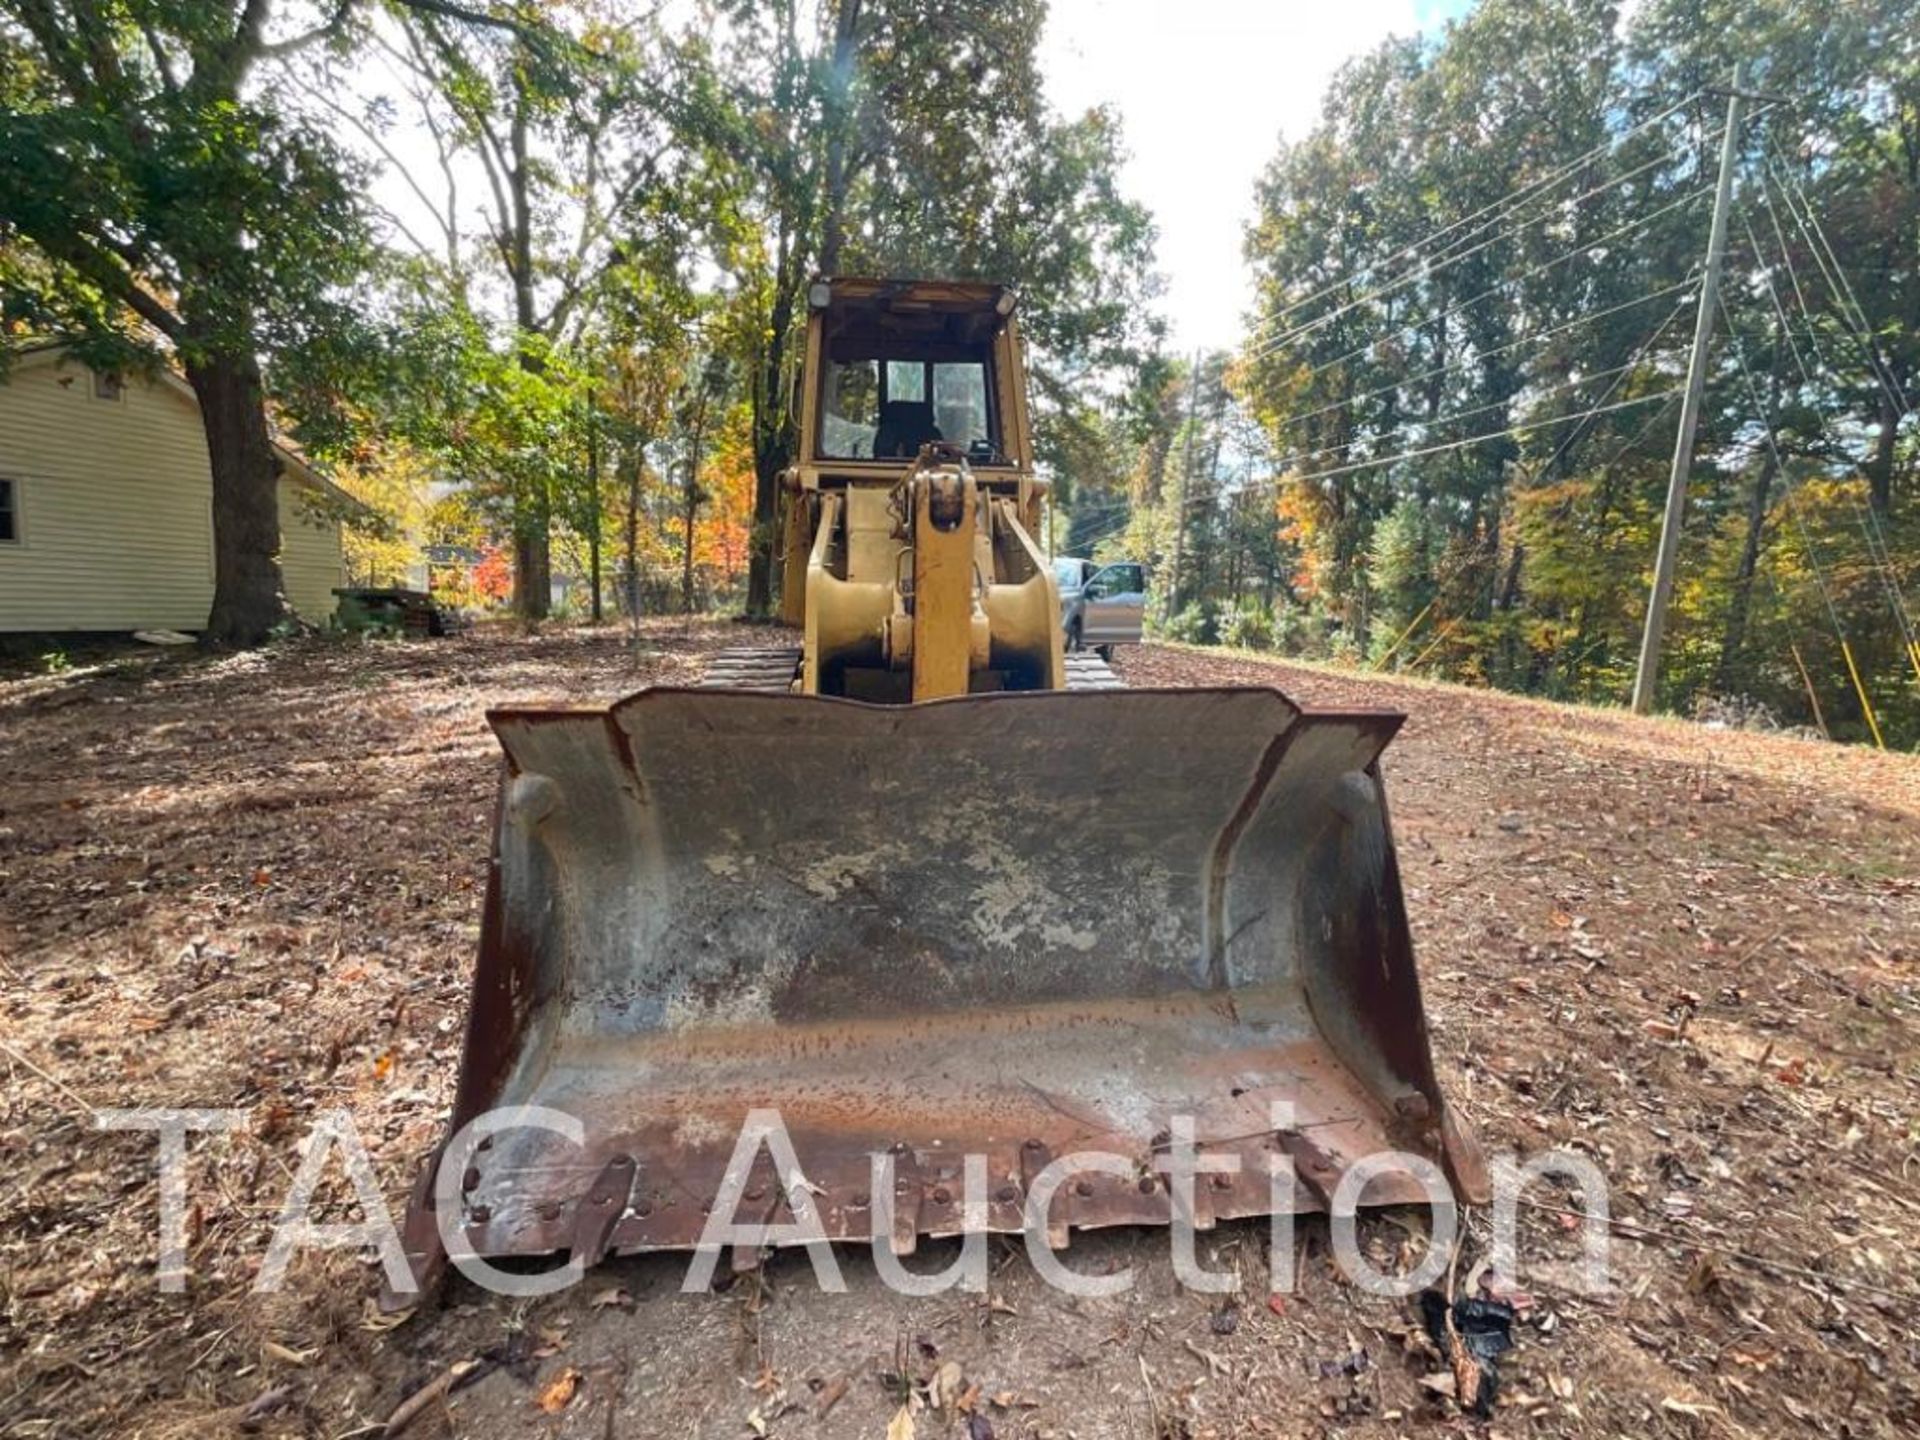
[0,624,1920,1440]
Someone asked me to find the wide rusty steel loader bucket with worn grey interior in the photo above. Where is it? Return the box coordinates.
[393,689,1486,1297]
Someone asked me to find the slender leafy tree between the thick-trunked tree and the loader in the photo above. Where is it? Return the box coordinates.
[345,4,701,618]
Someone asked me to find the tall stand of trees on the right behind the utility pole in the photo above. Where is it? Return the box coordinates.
[1228,0,1920,735]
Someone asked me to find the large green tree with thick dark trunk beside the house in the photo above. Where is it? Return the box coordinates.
[0,0,552,645]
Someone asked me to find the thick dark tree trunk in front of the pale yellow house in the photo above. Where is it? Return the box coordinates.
[186,353,292,647]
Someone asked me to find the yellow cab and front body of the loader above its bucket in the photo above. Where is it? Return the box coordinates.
[781,280,1066,703]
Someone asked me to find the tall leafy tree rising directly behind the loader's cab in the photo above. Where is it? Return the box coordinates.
[689,0,1152,614]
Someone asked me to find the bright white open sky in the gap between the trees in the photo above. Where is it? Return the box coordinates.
[1041,0,1469,349]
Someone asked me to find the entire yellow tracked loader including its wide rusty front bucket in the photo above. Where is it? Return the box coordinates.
[405,278,1486,1305]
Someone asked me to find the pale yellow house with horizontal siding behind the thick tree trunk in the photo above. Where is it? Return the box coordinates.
[0,346,355,634]
